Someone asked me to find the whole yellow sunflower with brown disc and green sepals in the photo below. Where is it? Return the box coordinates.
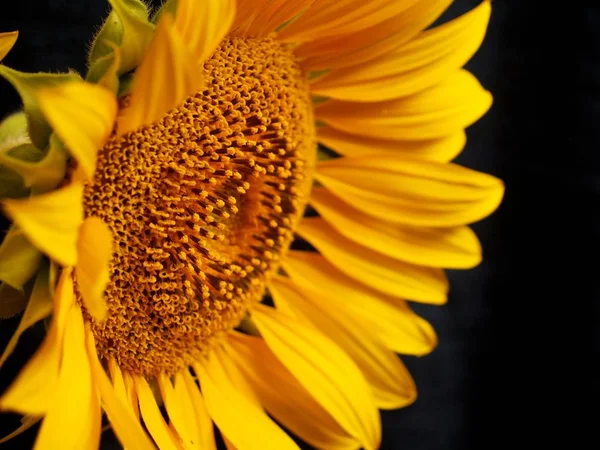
[0,0,503,450]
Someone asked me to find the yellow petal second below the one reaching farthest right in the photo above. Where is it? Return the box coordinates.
[298,217,448,304]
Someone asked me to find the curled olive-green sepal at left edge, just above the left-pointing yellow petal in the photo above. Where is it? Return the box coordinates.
[0,136,67,194]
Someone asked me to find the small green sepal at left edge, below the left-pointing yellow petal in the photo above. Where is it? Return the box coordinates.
[0,225,42,292]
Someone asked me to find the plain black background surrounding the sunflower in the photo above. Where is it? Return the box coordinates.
[0,0,600,450]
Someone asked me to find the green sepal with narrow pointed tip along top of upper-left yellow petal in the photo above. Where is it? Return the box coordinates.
[0,65,81,149]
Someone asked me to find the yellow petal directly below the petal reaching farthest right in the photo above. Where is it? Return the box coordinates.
[310,188,481,269]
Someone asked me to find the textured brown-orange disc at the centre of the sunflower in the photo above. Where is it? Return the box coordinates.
[84,38,316,376]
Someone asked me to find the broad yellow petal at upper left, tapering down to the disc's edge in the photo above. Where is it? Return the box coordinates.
[38,81,117,178]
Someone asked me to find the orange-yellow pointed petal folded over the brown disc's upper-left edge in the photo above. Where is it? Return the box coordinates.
[118,13,205,134]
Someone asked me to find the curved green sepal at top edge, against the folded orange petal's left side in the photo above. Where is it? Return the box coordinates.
[108,0,154,74]
